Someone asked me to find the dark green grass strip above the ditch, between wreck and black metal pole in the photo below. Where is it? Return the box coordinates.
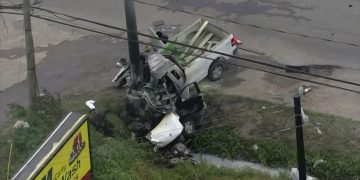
[191,126,296,167]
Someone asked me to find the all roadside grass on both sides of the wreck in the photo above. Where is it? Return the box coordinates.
[0,89,360,179]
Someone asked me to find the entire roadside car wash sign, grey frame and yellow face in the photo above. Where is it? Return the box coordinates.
[12,112,91,180]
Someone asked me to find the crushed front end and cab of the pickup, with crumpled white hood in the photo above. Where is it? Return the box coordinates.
[111,53,205,155]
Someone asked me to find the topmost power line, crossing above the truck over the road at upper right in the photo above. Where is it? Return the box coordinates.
[134,0,360,47]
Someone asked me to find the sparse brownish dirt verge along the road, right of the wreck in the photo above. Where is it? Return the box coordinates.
[203,91,360,155]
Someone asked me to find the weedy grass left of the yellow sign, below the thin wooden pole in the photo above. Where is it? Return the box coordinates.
[0,94,64,179]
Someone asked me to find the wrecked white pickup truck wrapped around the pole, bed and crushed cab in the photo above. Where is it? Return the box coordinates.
[112,19,240,158]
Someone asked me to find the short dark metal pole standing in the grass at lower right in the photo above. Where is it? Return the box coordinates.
[294,95,306,180]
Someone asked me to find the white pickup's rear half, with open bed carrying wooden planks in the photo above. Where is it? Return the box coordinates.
[149,19,241,84]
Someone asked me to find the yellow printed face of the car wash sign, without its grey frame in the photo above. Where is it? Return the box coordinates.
[35,121,91,180]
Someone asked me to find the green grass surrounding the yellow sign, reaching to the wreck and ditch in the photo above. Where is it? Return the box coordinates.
[0,89,286,180]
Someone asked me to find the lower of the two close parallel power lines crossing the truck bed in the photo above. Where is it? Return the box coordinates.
[0,11,360,94]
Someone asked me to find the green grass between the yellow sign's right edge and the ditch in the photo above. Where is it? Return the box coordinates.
[91,124,286,180]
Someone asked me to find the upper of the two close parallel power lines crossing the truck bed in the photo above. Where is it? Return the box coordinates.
[24,7,360,86]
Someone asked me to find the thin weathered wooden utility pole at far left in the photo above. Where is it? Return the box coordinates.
[22,0,38,109]
